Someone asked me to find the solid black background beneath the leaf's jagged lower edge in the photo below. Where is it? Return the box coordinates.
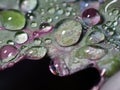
[0,57,100,90]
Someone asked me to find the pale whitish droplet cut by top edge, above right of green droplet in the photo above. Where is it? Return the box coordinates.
[20,0,38,12]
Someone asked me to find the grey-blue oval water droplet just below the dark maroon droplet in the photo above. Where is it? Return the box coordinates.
[87,31,105,44]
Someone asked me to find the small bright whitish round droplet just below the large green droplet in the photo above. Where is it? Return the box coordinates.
[14,32,28,44]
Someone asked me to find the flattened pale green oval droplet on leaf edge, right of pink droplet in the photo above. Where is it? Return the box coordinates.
[26,46,47,60]
